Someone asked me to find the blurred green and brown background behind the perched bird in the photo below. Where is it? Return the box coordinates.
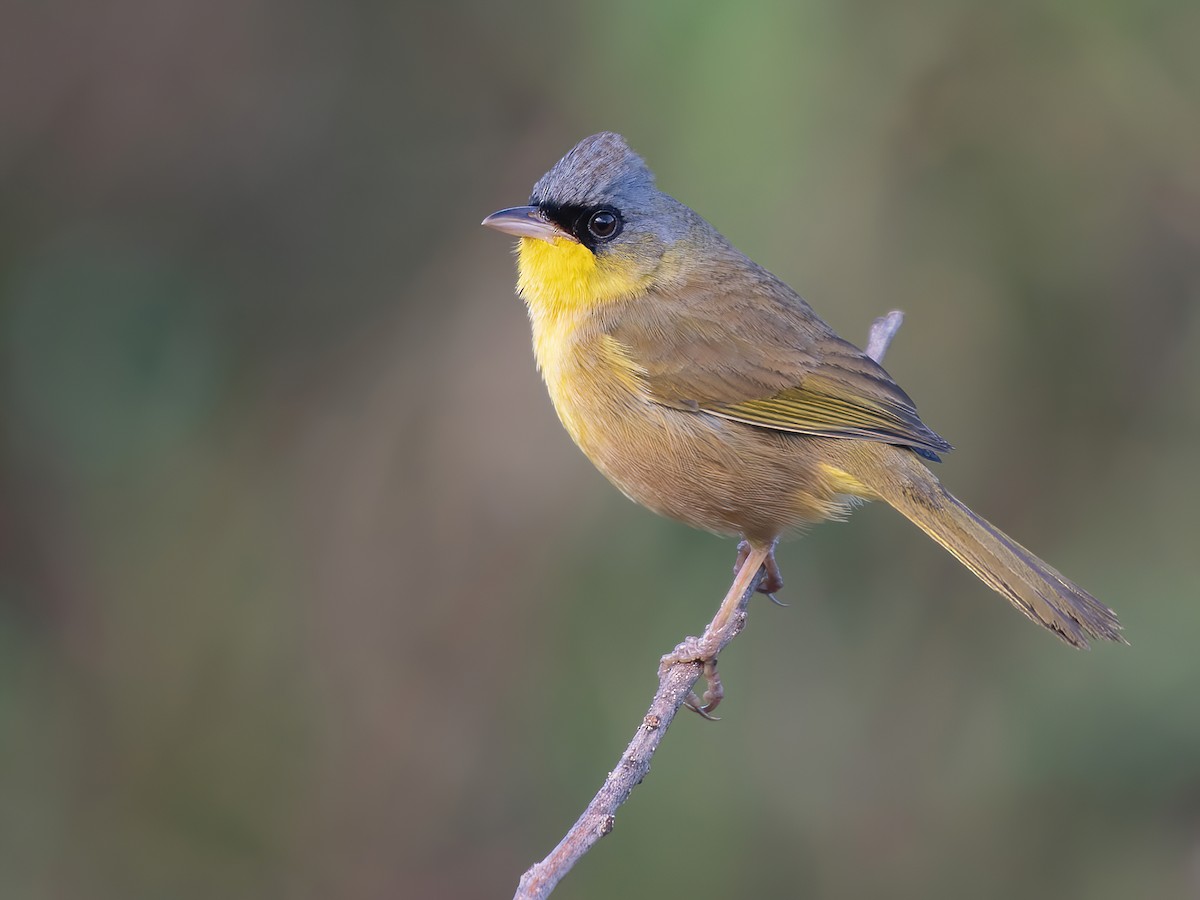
[0,0,1200,900]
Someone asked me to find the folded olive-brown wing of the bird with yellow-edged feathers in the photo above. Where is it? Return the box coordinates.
[611,251,950,460]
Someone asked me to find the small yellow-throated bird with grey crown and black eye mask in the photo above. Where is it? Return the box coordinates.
[482,132,1124,710]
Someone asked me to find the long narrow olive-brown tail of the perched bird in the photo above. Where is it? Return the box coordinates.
[845,444,1127,648]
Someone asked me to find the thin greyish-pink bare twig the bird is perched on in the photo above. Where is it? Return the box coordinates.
[514,310,904,900]
